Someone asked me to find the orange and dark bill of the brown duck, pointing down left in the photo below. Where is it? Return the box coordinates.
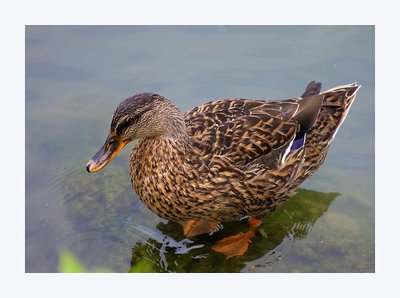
[86,136,128,173]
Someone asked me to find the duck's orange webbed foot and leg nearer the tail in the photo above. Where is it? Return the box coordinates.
[212,217,261,259]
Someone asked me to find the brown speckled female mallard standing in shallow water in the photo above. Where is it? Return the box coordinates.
[86,81,360,257]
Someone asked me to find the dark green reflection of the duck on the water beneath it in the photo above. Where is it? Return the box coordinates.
[130,189,338,272]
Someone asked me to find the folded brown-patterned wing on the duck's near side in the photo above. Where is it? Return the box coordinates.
[185,95,323,168]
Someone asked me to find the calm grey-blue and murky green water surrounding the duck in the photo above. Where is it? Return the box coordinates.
[26,26,375,272]
